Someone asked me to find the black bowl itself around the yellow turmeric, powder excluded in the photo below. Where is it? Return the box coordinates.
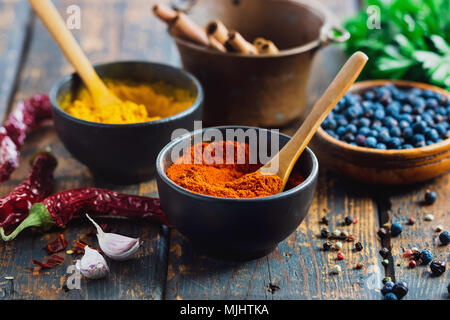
[49,61,203,184]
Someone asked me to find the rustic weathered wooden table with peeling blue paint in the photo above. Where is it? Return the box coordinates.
[0,0,450,299]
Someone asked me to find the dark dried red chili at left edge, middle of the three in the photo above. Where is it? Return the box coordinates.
[0,152,57,231]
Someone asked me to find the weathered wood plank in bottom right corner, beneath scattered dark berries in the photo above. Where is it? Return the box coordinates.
[386,173,450,299]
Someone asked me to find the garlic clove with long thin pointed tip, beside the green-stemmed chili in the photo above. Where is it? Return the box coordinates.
[86,214,141,261]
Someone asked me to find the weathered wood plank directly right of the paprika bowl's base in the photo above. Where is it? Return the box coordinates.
[269,172,384,300]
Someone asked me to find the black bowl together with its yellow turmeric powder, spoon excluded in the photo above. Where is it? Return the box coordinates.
[50,61,203,183]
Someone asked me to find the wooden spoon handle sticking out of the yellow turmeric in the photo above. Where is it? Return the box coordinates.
[29,0,110,101]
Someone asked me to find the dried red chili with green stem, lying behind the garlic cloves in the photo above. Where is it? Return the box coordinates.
[0,188,169,241]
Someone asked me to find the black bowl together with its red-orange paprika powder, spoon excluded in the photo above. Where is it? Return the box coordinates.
[156,126,319,260]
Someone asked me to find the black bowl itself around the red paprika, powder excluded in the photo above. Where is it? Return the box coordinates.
[156,126,319,260]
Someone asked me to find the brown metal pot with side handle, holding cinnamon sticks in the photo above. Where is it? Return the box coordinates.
[175,0,349,127]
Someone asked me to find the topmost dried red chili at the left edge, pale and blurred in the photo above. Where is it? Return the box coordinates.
[0,94,52,182]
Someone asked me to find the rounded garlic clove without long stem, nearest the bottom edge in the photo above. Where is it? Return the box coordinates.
[75,246,109,279]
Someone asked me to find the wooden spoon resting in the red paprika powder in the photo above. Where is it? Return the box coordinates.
[260,51,368,189]
